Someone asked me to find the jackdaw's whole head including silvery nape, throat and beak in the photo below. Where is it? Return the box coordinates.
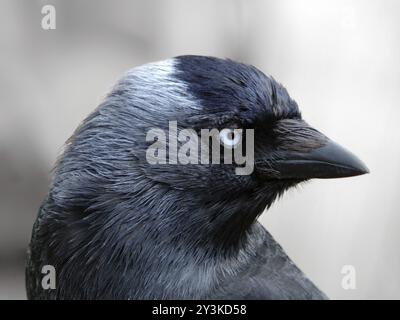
[53,56,368,248]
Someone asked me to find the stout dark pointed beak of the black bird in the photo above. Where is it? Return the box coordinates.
[266,121,369,179]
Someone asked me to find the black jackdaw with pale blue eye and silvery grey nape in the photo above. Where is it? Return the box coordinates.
[26,56,368,299]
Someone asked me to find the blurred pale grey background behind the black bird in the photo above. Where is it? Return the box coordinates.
[0,0,400,299]
